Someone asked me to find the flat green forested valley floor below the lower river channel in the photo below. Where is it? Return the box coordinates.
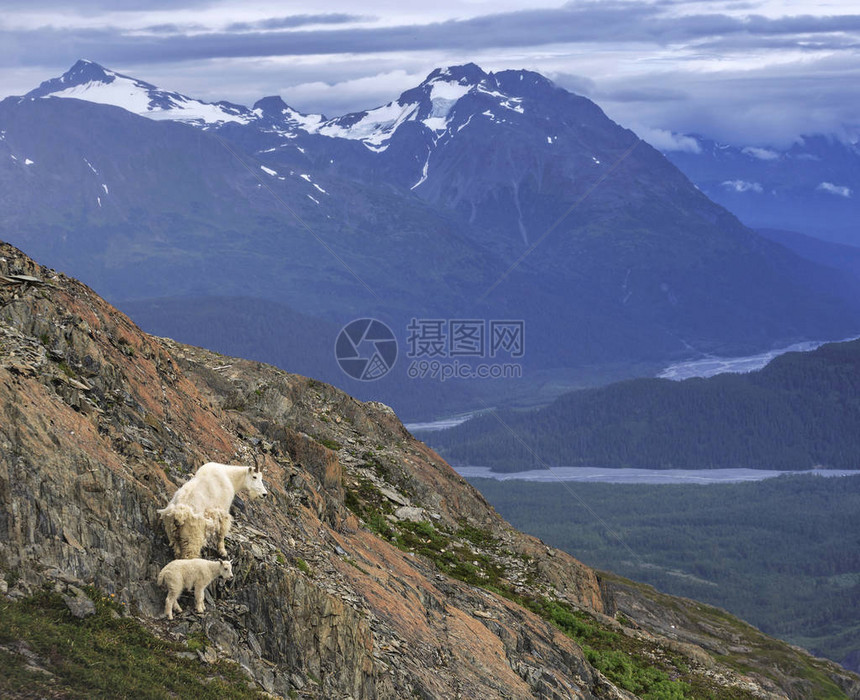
[466,476,860,668]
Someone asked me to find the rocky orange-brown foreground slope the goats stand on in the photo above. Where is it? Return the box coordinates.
[0,238,860,700]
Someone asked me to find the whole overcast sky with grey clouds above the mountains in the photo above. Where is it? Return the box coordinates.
[0,0,860,146]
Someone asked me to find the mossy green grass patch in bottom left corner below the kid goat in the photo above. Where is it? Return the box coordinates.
[0,588,262,700]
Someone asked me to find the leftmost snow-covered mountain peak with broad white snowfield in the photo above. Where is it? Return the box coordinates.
[25,59,254,128]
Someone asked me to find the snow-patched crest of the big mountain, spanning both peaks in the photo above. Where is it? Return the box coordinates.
[25,60,576,153]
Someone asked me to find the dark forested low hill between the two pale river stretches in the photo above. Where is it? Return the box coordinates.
[429,341,860,471]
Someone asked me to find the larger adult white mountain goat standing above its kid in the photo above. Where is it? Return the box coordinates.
[158,460,268,559]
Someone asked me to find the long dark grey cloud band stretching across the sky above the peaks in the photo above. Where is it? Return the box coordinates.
[2,2,860,65]
